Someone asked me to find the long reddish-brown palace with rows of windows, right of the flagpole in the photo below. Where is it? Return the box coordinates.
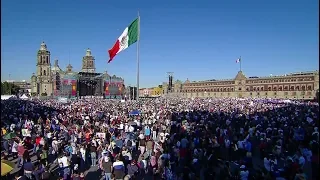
[163,71,319,99]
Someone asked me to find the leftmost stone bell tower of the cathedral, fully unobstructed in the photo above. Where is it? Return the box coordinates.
[36,42,52,96]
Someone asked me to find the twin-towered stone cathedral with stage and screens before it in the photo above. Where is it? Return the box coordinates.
[31,42,124,97]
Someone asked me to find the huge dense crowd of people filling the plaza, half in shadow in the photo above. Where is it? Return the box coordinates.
[1,98,319,180]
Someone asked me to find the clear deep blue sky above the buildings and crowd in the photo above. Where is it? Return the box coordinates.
[1,0,319,87]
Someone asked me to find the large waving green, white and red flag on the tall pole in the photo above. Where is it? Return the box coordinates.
[108,18,139,63]
